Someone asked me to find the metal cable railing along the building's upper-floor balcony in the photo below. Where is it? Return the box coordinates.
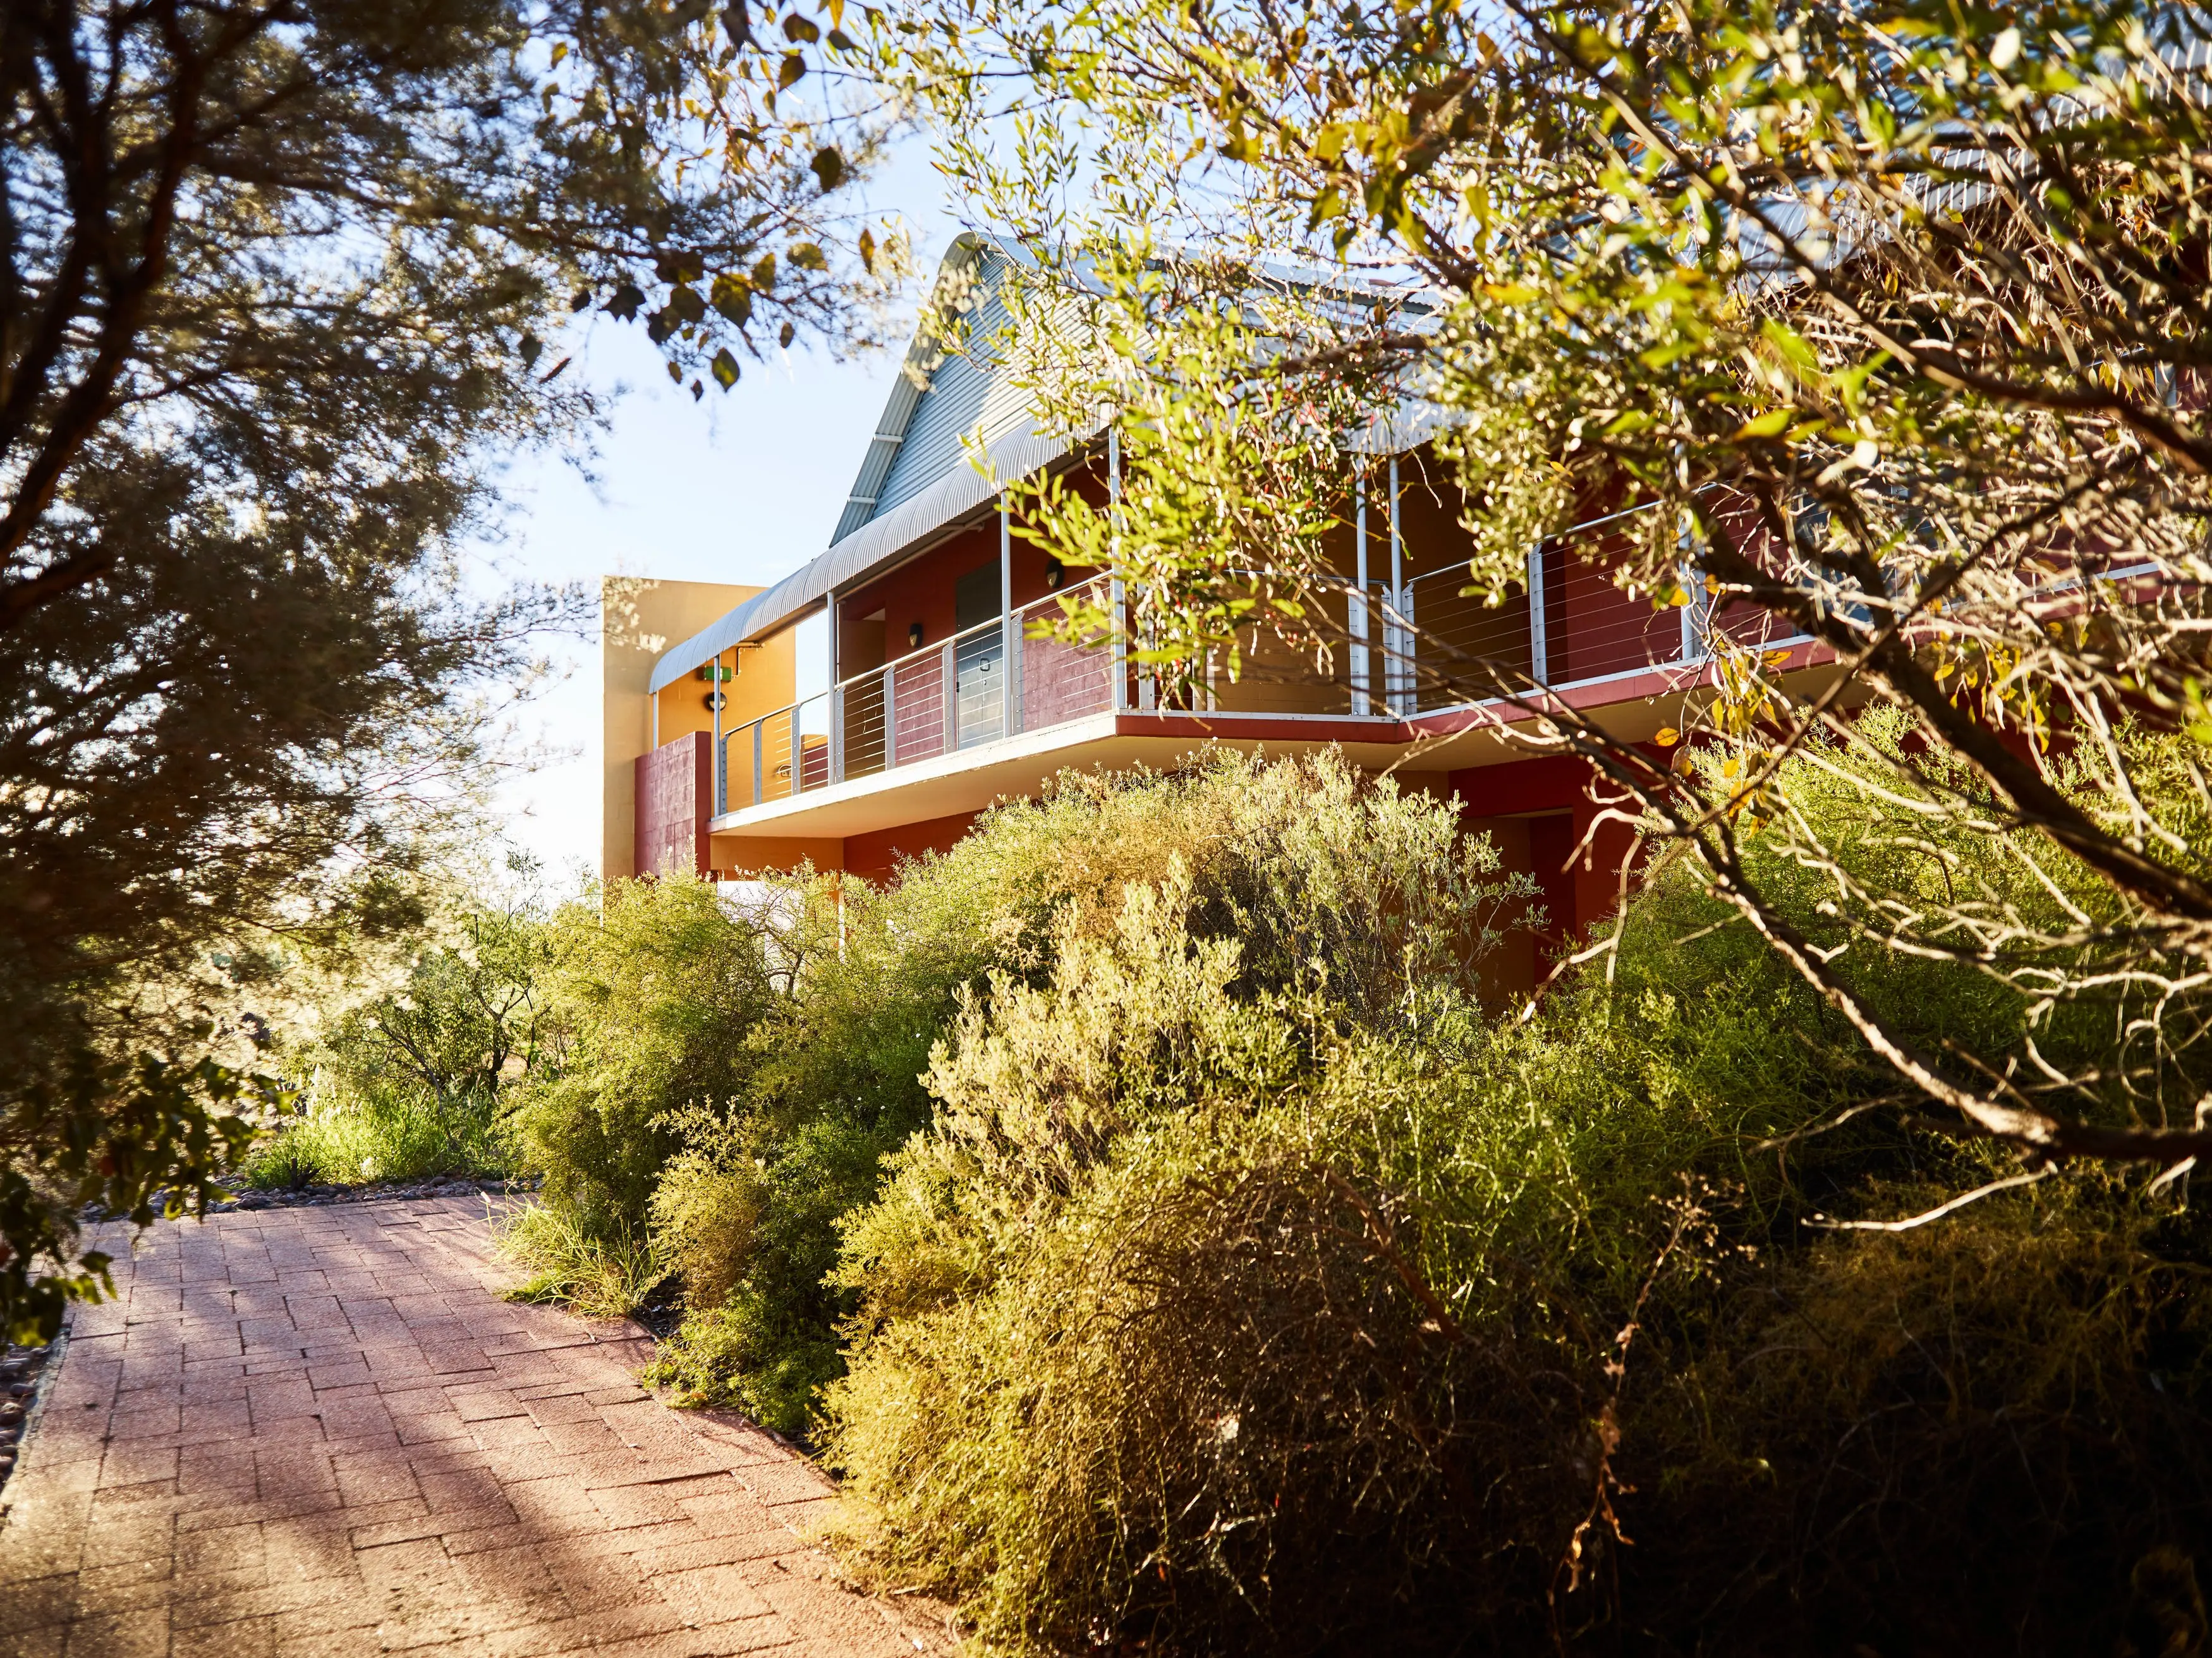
[715,524,1796,817]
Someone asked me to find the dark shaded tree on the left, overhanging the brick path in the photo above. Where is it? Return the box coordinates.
[0,0,901,1331]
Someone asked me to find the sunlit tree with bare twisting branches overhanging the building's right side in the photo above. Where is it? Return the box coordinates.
[885,0,2212,1204]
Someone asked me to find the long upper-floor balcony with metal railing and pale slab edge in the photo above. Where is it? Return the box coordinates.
[712,513,1801,839]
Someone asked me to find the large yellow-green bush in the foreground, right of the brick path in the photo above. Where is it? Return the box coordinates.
[827,733,2212,1654]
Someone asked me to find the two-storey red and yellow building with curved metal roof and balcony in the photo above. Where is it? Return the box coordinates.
[604,235,1818,983]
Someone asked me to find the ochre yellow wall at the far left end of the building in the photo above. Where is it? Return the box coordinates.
[600,576,765,881]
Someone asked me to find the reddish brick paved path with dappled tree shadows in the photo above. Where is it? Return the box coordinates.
[0,1198,949,1658]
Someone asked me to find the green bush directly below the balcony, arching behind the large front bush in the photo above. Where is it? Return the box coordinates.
[653,755,1529,1432]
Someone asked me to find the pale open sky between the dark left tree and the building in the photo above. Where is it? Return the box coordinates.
[480,149,958,886]
